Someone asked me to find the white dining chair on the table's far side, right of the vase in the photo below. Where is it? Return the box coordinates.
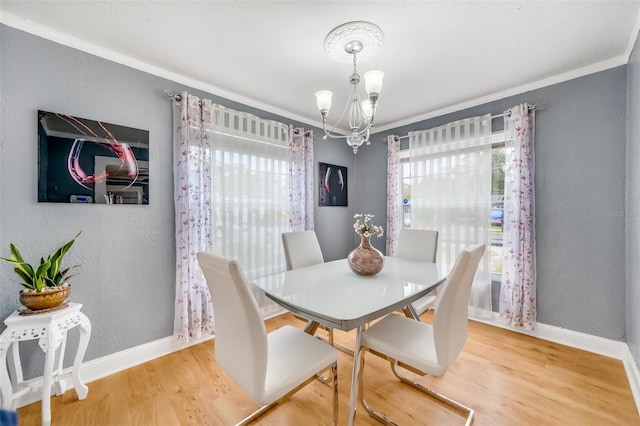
[395,228,438,319]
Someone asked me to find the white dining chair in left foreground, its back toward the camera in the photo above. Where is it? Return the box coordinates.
[197,252,338,425]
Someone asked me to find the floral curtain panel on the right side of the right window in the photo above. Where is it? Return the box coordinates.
[500,104,536,330]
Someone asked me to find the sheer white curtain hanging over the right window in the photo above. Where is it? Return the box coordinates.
[409,115,491,317]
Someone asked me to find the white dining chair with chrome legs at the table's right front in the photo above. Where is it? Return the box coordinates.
[358,245,485,425]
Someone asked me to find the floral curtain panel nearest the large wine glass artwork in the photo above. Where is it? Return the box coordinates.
[173,92,214,342]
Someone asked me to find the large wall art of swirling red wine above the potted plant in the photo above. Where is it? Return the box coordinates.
[38,111,149,205]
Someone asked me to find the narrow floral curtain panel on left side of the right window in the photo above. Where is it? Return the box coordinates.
[386,135,402,256]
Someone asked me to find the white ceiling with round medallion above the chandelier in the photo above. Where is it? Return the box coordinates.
[0,0,640,131]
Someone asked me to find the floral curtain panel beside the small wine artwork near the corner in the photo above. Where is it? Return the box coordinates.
[289,128,314,231]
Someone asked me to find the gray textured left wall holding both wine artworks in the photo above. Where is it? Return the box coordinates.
[0,25,353,377]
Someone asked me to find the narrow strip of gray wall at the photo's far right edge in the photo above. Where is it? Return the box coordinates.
[626,35,640,365]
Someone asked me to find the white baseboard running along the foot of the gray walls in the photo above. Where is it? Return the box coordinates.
[10,313,640,414]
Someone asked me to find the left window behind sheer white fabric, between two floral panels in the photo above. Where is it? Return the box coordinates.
[200,132,289,280]
